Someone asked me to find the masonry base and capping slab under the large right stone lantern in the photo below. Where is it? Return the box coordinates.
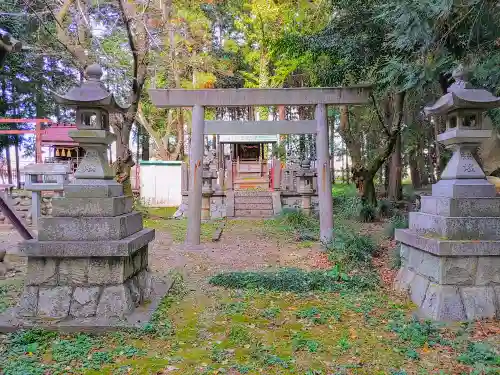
[395,230,500,321]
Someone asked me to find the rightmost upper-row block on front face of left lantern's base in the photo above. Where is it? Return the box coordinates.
[88,257,128,285]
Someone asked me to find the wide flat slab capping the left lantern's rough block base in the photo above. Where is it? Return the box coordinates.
[19,228,155,258]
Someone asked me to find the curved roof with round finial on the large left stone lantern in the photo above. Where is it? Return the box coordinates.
[54,64,130,113]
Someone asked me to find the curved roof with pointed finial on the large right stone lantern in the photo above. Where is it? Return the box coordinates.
[424,66,500,115]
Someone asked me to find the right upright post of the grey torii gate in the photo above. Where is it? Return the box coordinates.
[314,104,333,243]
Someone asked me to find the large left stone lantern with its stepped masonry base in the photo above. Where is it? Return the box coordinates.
[0,65,165,330]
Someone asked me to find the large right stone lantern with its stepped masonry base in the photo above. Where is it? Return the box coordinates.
[395,68,500,321]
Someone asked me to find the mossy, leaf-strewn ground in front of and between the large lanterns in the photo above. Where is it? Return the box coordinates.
[0,203,500,375]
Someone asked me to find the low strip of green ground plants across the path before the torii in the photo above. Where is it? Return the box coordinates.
[210,268,373,293]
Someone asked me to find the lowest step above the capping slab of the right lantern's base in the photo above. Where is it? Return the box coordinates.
[410,212,500,240]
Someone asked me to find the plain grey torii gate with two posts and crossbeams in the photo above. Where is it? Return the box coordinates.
[149,85,371,245]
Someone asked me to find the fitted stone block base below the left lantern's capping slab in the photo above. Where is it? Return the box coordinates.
[17,246,151,319]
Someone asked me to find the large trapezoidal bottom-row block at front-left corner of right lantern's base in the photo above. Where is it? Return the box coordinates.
[421,283,466,321]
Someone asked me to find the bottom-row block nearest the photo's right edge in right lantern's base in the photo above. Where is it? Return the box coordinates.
[462,286,496,320]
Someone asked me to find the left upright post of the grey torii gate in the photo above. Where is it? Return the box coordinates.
[186,105,205,245]
